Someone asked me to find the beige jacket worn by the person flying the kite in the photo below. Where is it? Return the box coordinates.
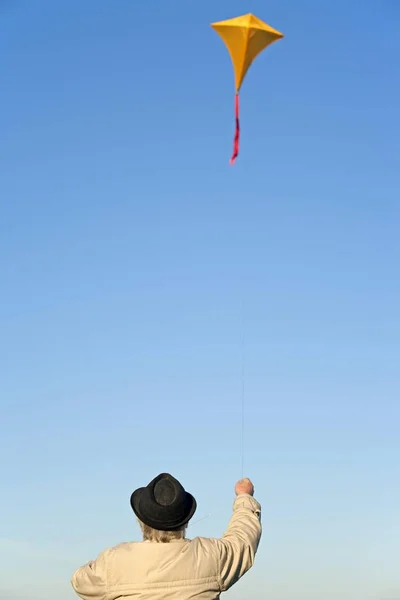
[71,494,261,600]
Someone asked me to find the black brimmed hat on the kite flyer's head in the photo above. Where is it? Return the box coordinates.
[131,473,197,531]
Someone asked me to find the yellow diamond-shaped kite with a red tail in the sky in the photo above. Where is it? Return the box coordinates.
[211,14,283,164]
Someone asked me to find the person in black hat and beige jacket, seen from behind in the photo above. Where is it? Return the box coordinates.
[71,473,261,600]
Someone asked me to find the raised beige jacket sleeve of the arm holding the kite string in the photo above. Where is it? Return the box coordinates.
[217,494,262,592]
